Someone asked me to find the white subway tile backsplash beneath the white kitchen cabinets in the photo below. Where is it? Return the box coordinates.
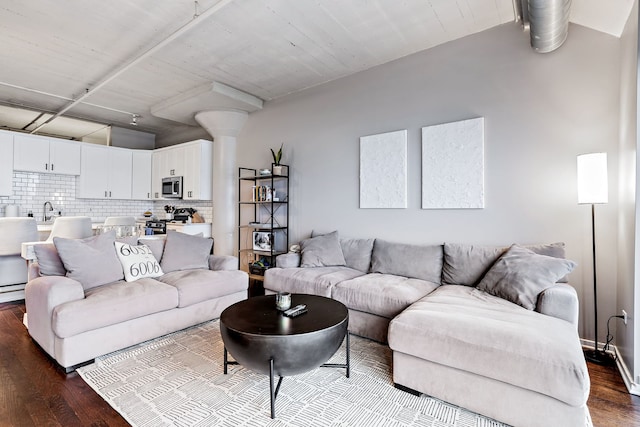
[0,172,213,222]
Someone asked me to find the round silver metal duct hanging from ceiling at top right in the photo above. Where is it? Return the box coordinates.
[522,0,571,53]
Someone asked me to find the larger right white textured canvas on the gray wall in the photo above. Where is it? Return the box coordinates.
[422,117,484,209]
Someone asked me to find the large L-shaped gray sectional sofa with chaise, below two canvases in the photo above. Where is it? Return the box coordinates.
[264,232,590,427]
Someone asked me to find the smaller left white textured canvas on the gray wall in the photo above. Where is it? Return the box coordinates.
[360,129,407,209]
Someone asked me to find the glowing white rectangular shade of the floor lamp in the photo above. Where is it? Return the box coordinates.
[578,153,609,204]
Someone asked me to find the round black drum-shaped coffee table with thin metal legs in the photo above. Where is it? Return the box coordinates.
[220,294,349,418]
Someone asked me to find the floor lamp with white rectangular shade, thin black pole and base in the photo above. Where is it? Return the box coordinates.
[578,153,612,365]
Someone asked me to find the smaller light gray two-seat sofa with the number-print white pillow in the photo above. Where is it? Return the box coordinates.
[25,232,249,371]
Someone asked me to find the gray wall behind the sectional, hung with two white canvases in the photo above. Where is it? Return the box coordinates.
[238,24,620,344]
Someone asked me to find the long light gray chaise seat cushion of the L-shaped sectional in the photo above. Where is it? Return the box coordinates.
[389,285,589,406]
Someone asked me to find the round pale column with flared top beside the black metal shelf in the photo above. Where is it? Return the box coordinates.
[195,110,249,255]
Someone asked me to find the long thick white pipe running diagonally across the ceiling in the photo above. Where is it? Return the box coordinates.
[31,0,233,133]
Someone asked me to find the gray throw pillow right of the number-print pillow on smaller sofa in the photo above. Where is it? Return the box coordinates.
[160,231,213,273]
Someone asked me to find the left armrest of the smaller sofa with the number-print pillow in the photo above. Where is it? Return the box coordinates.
[24,276,84,358]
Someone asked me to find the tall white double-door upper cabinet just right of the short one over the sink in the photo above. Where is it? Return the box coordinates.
[77,144,133,199]
